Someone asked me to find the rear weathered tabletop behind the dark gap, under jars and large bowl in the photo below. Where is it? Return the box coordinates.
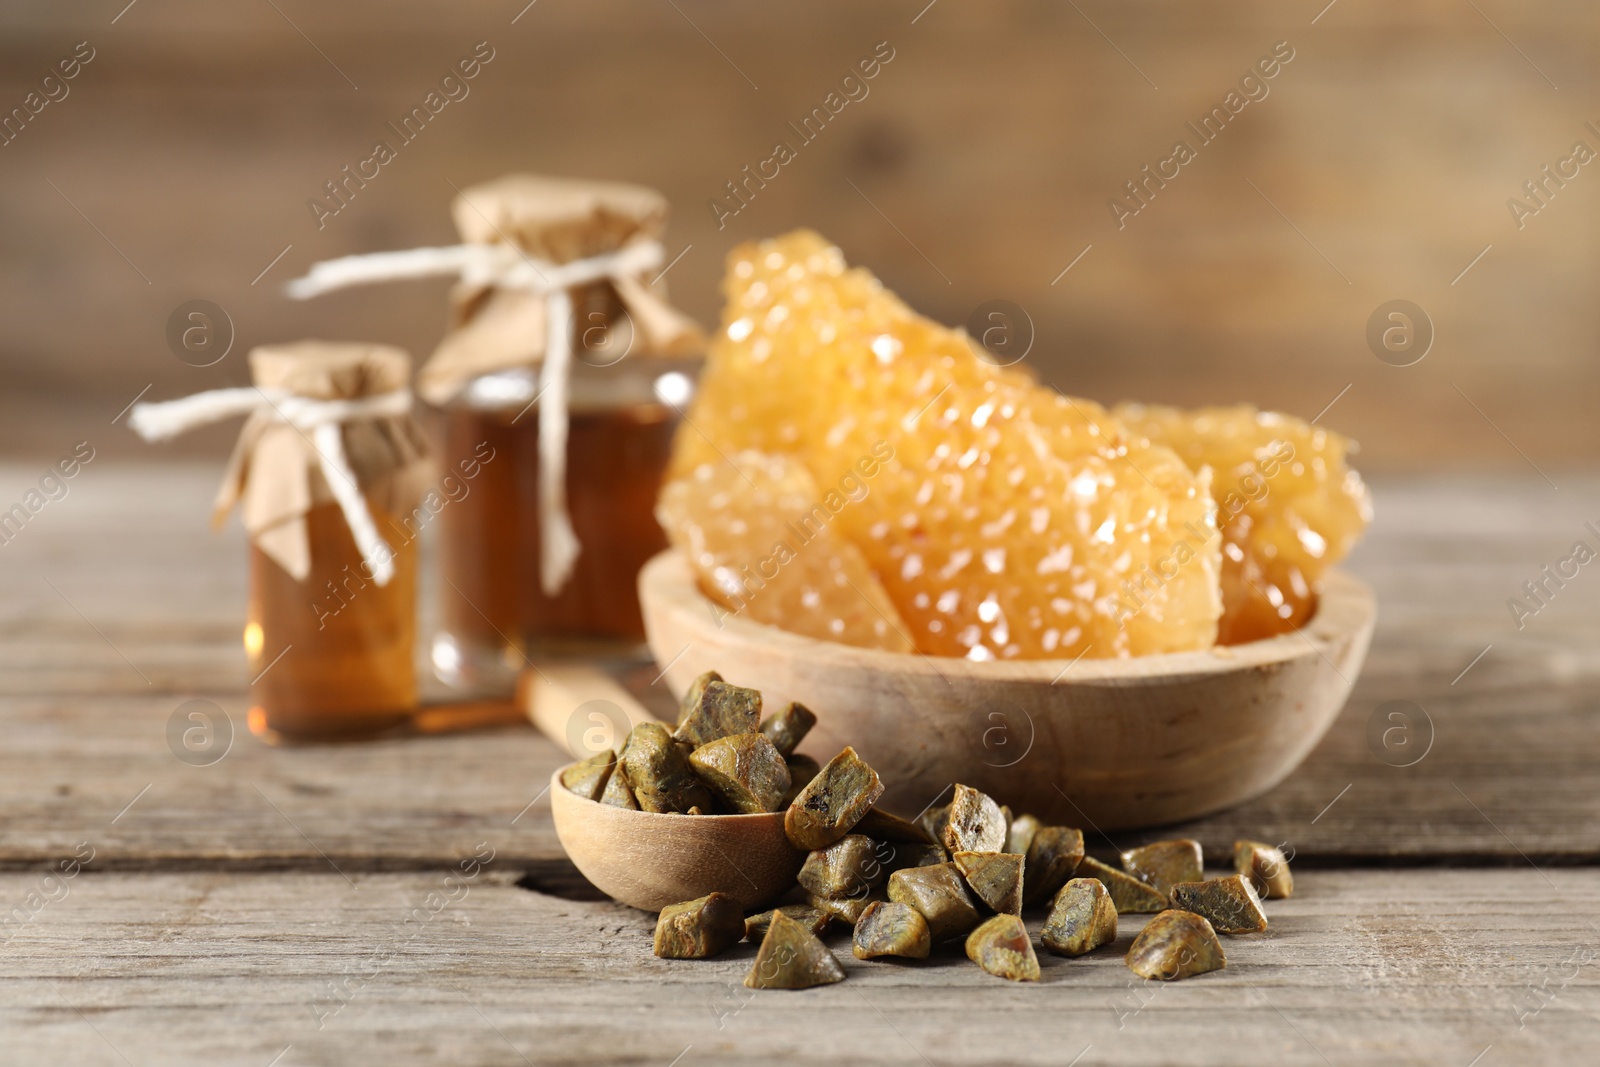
[0,464,1600,877]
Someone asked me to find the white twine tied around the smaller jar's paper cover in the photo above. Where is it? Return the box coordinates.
[128,386,411,585]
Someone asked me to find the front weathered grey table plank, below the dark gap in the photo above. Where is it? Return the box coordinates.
[0,870,1600,1067]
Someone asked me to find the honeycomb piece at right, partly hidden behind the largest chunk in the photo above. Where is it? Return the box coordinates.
[1114,405,1373,645]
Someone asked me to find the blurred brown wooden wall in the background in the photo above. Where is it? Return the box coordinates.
[0,0,1600,477]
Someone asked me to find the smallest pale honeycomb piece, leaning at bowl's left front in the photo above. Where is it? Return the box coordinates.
[656,451,912,653]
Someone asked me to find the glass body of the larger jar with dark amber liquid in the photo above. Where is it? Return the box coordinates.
[432,355,699,694]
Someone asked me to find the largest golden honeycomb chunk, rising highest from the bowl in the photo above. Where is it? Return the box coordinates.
[672,230,1221,661]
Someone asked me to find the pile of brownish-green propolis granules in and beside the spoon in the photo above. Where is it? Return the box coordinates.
[601,673,1294,989]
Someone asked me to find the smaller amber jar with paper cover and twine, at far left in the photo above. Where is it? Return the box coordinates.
[136,341,430,741]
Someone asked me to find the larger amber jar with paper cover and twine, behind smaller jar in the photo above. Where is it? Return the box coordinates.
[290,174,706,696]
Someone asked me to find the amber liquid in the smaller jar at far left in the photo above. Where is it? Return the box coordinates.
[245,504,418,741]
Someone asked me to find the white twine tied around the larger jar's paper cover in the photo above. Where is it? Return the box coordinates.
[288,238,664,597]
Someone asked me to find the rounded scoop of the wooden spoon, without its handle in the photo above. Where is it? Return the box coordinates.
[550,768,805,912]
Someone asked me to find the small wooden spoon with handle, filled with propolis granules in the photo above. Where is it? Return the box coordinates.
[518,664,805,912]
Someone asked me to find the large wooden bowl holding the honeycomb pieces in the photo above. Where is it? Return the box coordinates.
[638,550,1376,830]
